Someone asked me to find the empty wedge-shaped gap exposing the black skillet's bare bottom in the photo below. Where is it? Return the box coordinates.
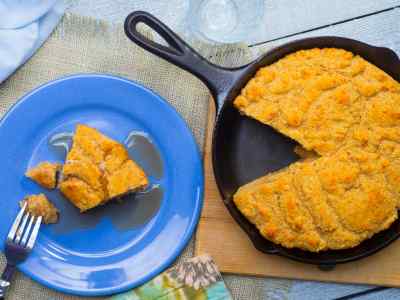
[214,105,299,198]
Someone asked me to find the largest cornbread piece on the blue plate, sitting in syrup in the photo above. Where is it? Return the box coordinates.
[59,125,148,212]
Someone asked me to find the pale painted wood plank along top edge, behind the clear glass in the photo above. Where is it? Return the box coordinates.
[69,0,400,44]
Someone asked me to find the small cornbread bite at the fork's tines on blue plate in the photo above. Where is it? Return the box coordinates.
[20,194,58,224]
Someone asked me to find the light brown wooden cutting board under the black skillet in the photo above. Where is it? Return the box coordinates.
[195,101,400,287]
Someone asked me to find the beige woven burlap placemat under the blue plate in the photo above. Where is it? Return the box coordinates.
[0,14,296,300]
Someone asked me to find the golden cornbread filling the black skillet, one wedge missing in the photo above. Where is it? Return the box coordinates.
[234,48,400,252]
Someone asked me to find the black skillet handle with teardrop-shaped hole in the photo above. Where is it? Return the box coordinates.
[124,11,244,112]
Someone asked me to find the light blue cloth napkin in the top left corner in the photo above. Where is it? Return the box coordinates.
[0,0,66,83]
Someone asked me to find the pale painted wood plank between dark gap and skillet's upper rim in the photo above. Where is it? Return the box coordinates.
[251,8,400,56]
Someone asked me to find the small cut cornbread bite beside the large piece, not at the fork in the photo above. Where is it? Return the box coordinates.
[25,161,61,189]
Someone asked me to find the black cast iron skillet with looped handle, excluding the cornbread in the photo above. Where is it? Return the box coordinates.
[125,11,400,269]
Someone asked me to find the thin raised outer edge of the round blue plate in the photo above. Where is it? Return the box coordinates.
[0,72,204,297]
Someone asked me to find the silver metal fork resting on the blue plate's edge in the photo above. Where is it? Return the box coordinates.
[0,203,42,300]
